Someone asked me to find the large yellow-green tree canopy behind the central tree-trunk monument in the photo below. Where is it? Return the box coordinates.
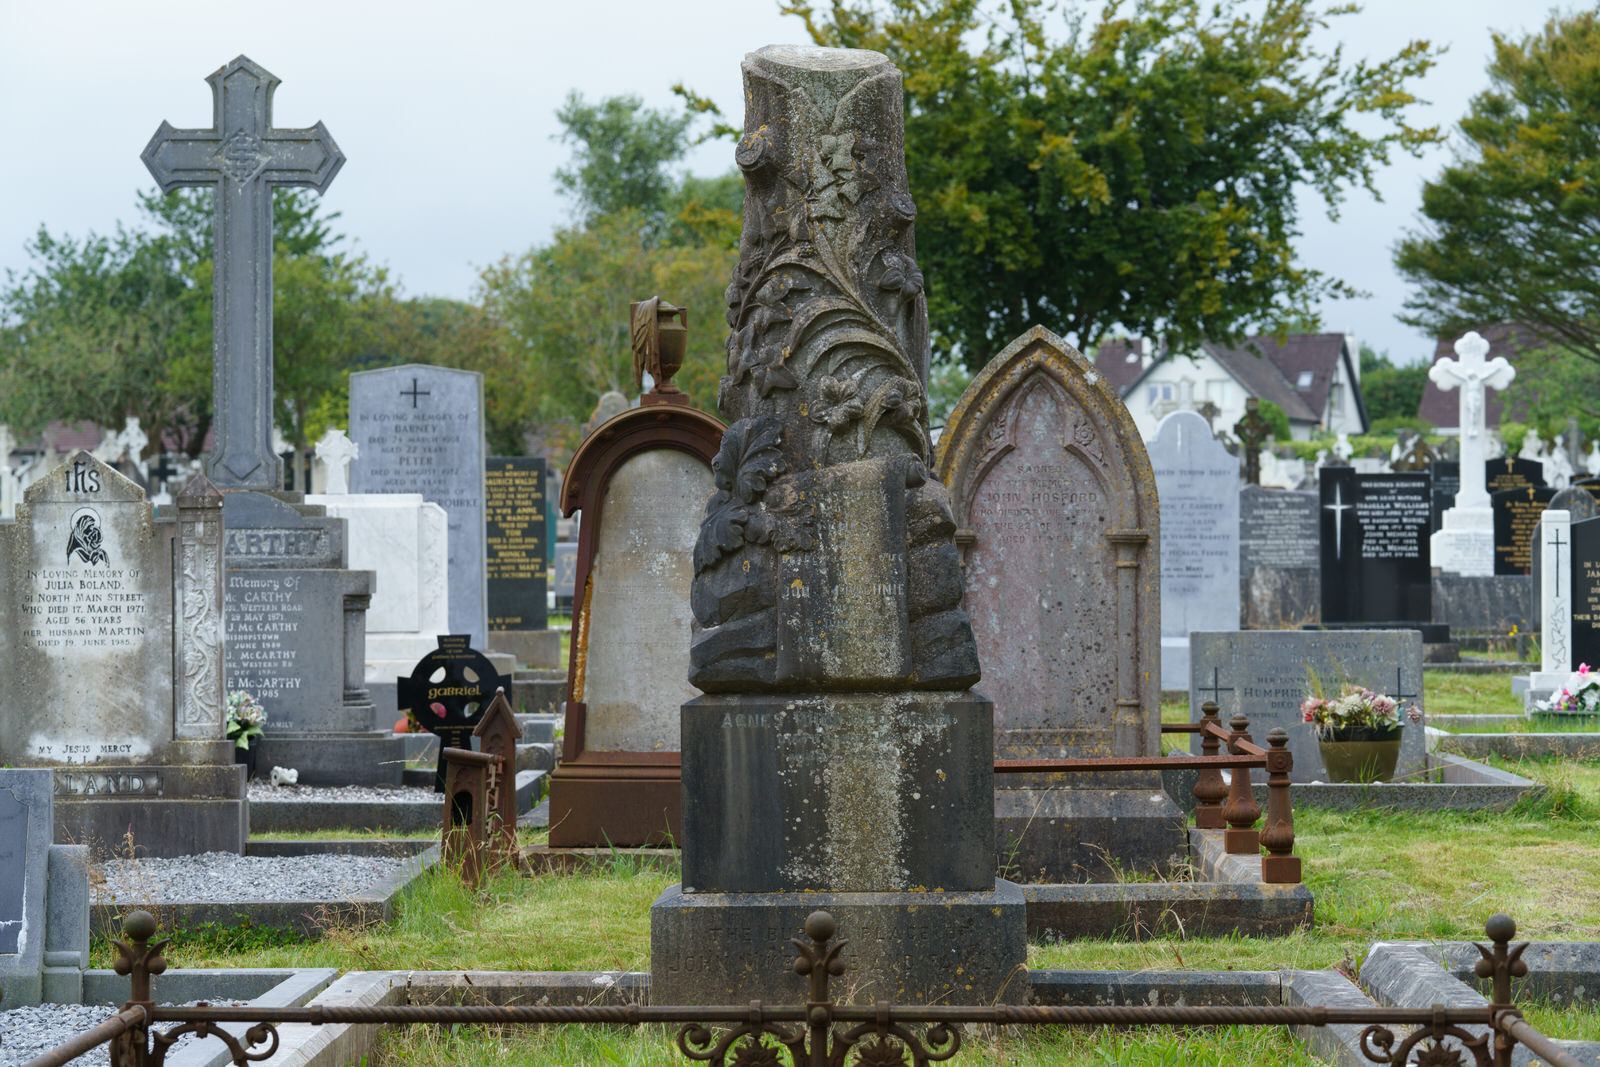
[732,0,1438,366]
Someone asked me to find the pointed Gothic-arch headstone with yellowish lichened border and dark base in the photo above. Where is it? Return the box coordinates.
[938,326,1177,881]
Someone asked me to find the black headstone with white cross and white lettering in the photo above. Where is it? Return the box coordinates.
[1320,467,1434,622]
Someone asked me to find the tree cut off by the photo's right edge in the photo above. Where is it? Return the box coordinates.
[1395,11,1600,368]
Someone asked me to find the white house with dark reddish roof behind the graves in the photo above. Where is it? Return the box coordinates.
[1094,333,1368,442]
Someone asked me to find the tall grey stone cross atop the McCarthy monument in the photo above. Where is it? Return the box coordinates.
[141,56,344,490]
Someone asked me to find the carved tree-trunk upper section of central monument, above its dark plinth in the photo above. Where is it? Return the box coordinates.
[690,46,978,691]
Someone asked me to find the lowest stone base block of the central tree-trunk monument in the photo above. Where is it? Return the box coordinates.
[650,878,1029,1005]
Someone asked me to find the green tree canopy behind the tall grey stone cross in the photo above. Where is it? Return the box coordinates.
[0,189,392,463]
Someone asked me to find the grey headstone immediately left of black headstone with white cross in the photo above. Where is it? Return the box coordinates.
[1238,485,1322,630]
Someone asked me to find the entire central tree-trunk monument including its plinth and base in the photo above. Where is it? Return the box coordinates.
[649,45,1027,1003]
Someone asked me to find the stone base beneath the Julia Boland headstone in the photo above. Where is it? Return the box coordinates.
[54,767,250,861]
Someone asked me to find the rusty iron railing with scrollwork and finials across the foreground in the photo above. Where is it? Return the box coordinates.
[24,912,1579,1067]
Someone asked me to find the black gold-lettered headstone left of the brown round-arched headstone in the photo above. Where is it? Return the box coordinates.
[485,456,549,630]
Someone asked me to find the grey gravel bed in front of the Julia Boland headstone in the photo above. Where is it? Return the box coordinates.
[93,853,406,904]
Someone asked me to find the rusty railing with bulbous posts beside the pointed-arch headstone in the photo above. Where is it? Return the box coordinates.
[995,701,1301,885]
